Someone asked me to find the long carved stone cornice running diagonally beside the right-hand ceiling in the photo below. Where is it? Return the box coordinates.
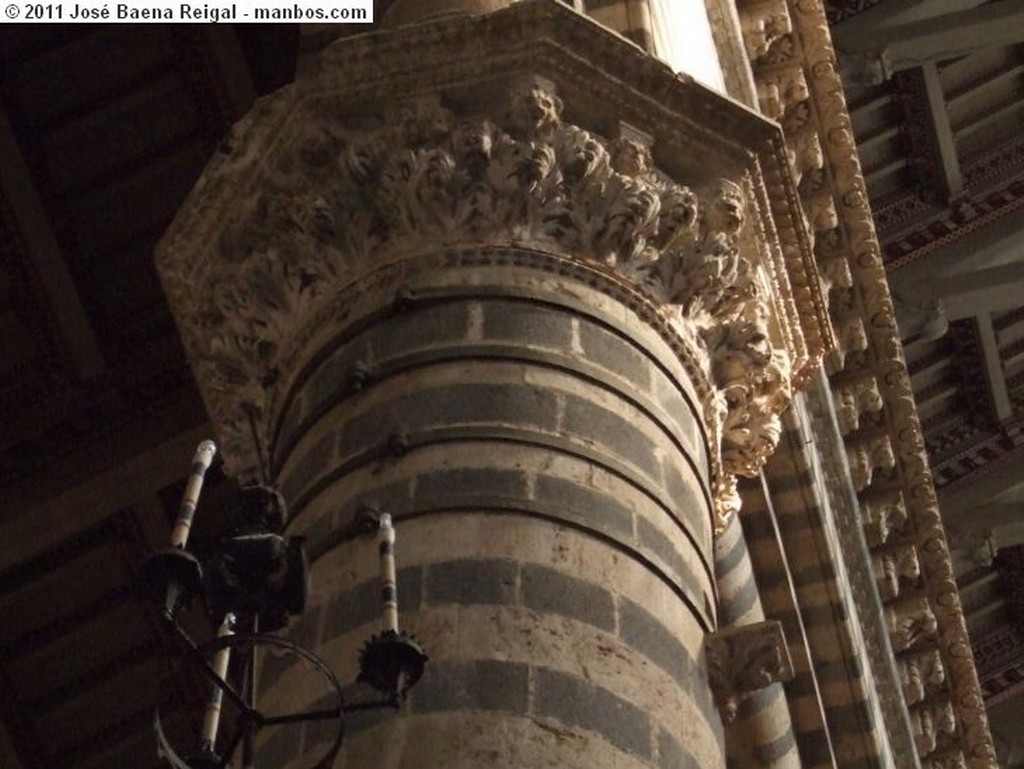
[746,0,994,769]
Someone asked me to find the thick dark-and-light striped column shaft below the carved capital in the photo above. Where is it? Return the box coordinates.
[261,249,724,769]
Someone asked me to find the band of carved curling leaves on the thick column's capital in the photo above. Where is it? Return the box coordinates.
[157,78,792,519]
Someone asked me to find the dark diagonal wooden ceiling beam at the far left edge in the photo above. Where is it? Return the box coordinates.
[0,106,105,381]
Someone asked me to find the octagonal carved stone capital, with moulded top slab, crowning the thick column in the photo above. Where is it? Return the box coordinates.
[157,2,830,521]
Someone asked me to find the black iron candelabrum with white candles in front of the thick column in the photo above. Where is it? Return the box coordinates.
[141,441,427,769]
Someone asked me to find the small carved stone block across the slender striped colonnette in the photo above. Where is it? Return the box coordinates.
[705,620,793,723]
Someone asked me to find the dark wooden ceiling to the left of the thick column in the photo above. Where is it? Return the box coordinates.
[0,26,298,769]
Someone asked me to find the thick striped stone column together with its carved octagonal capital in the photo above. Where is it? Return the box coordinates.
[149,3,823,769]
